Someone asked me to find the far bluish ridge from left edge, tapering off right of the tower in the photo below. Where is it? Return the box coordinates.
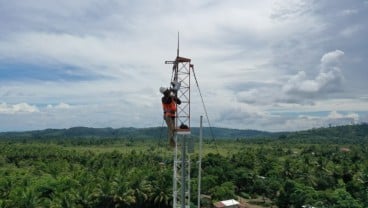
[0,127,272,139]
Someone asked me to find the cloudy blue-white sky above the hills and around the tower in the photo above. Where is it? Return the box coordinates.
[0,0,368,131]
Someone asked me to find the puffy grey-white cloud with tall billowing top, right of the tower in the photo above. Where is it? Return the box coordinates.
[236,50,345,106]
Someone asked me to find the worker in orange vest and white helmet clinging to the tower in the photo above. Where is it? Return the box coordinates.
[160,87,181,147]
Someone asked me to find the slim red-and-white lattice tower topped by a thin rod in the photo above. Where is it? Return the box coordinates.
[165,34,193,208]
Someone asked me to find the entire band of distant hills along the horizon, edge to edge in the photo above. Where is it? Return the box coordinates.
[0,124,368,142]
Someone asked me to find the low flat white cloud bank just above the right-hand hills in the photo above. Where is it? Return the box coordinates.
[216,106,364,131]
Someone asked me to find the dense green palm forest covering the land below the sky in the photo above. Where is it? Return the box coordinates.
[0,124,368,208]
